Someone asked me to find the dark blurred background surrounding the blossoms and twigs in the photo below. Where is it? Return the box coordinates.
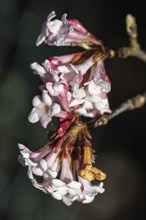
[0,0,146,220]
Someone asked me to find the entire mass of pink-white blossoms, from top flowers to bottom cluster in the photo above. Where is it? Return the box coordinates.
[19,12,111,205]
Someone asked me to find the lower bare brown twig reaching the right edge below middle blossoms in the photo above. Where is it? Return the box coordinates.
[87,92,146,129]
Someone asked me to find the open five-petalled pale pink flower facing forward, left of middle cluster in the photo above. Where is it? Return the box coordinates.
[28,90,61,128]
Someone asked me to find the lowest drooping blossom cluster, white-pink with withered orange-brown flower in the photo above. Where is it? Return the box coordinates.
[18,118,106,205]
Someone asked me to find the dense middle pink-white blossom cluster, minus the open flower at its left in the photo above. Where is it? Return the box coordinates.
[32,53,111,120]
